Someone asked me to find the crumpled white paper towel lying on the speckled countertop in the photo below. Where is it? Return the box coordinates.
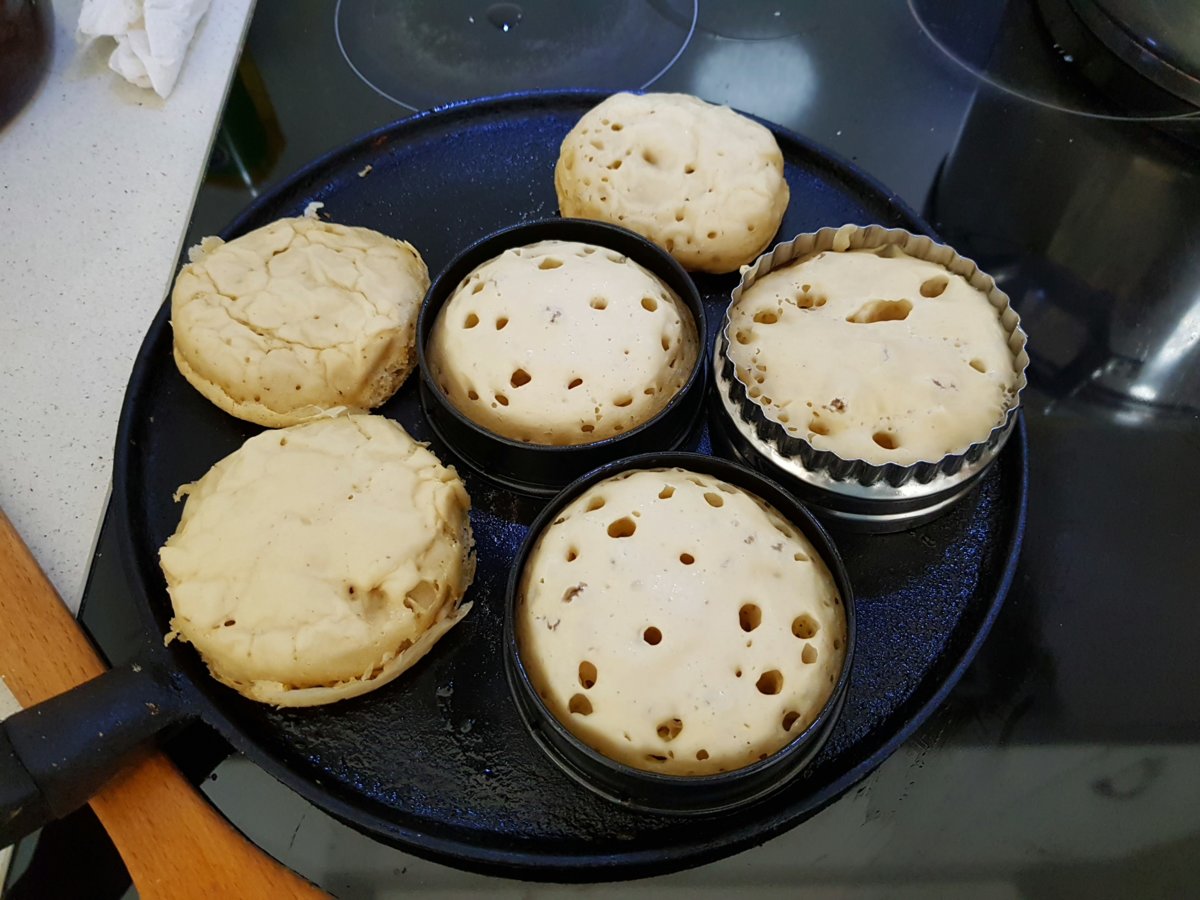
[79,0,211,98]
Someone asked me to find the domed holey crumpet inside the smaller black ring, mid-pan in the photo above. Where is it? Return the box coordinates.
[426,241,700,445]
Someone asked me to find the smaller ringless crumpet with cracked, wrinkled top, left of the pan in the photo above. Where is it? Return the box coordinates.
[170,216,430,427]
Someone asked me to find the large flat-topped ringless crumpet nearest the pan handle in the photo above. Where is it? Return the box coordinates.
[160,415,475,707]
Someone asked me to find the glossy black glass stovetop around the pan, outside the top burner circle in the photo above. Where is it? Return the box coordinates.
[56,0,1200,898]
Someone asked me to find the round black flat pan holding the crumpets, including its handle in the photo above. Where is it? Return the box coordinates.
[0,92,1027,881]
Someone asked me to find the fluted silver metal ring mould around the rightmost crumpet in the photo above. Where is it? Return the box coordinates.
[713,224,1030,532]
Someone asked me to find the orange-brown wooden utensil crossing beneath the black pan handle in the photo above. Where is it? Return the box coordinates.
[0,510,326,900]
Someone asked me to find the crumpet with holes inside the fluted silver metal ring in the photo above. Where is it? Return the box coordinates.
[727,245,1018,466]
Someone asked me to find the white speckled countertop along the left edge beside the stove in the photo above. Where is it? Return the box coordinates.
[0,0,253,610]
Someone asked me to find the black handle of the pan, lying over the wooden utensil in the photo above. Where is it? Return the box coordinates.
[0,664,191,847]
